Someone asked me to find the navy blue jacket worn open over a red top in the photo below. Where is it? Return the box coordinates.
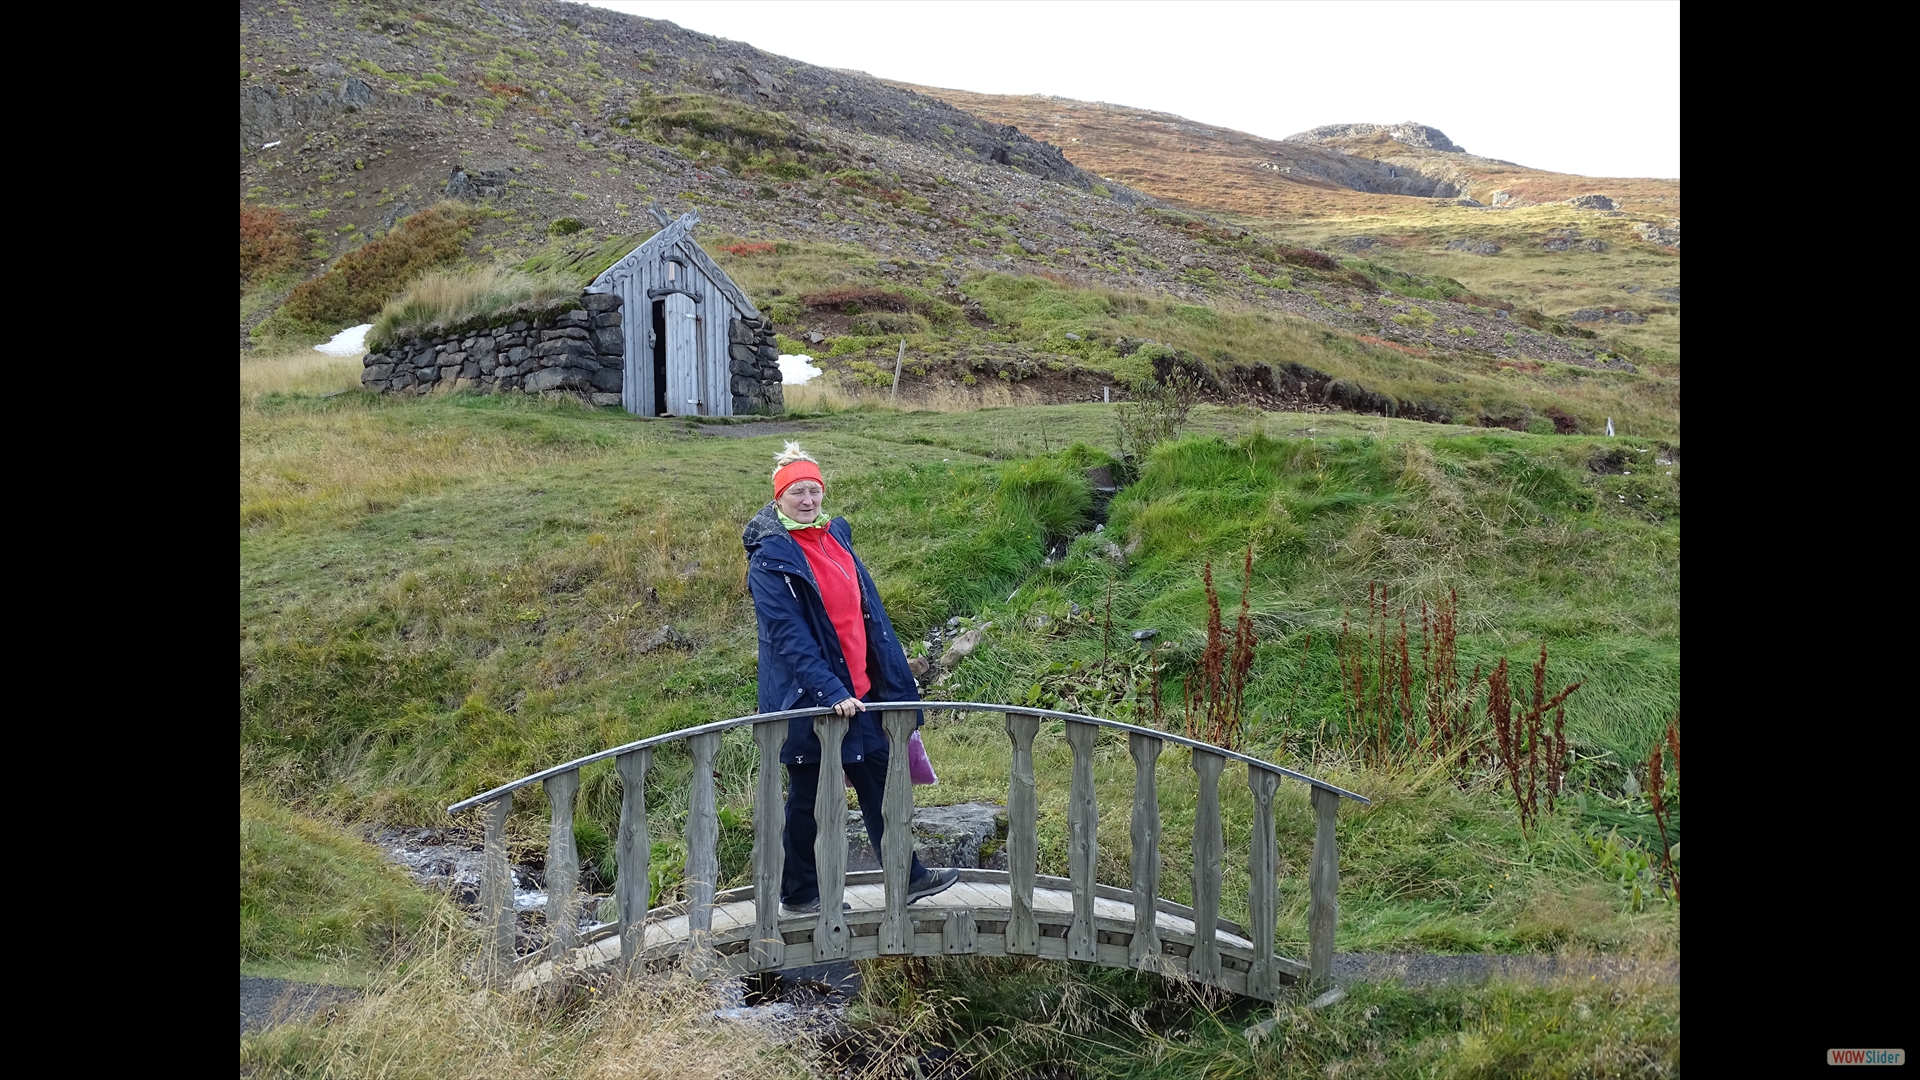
[739,503,920,765]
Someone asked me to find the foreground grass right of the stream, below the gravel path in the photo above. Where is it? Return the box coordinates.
[862,957,1680,1080]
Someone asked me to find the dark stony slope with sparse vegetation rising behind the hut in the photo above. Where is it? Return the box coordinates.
[240,2,1678,438]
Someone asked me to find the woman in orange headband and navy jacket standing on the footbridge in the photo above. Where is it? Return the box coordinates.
[741,442,960,915]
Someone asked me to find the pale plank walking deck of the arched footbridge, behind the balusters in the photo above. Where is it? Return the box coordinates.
[513,871,1308,994]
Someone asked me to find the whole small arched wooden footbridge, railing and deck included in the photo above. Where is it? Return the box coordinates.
[447,701,1367,1001]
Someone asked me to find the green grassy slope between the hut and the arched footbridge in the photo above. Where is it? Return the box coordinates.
[240,365,1678,944]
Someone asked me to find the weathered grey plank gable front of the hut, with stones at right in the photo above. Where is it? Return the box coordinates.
[586,211,783,417]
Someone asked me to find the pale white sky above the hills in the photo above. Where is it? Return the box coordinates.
[576,0,1680,177]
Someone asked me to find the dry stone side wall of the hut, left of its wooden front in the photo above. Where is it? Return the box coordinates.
[361,294,626,405]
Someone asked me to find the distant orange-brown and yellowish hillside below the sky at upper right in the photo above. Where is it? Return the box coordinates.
[900,83,1680,365]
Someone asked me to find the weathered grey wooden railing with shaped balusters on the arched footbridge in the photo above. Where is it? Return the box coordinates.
[447,701,1367,999]
